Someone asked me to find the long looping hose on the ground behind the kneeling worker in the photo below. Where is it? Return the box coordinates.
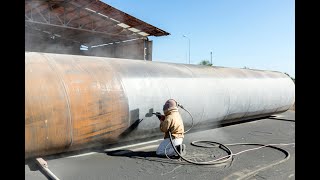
[165,104,295,166]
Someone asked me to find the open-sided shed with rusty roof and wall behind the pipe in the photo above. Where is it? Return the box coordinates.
[25,0,169,60]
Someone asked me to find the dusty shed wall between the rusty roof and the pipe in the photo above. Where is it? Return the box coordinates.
[25,33,152,61]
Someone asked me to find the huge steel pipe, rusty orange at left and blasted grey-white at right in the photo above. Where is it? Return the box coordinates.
[25,52,295,158]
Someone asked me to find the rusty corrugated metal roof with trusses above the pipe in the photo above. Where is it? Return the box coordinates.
[25,0,169,44]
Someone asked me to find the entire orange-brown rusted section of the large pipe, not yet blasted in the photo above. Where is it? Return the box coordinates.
[25,53,129,158]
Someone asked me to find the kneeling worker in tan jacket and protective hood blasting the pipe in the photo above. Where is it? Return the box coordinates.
[156,99,186,157]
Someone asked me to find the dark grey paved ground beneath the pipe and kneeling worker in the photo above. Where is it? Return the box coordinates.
[25,110,295,180]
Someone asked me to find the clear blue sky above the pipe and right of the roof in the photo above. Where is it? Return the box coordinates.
[103,0,295,77]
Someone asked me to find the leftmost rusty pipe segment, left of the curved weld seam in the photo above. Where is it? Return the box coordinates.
[25,53,70,158]
